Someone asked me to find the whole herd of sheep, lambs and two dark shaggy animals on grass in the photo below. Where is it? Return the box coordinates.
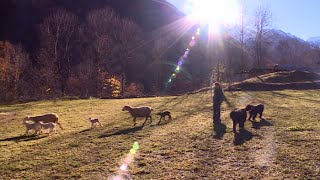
[23,104,264,135]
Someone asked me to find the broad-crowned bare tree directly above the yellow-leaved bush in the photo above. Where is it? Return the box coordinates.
[87,8,143,95]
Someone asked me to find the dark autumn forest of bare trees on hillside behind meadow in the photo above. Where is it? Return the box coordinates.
[0,0,320,101]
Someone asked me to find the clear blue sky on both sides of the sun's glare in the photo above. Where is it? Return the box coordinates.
[167,0,320,40]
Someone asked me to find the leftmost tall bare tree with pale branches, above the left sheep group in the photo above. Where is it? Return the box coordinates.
[38,9,77,94]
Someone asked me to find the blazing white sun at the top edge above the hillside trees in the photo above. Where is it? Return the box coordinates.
[188,0,239,26]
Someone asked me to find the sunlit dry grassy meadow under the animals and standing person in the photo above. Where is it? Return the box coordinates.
[0,90,320,179]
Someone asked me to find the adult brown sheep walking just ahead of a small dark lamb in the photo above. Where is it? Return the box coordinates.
[122,105,153,126]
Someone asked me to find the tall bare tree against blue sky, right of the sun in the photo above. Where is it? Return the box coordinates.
[253,6,272,67]
